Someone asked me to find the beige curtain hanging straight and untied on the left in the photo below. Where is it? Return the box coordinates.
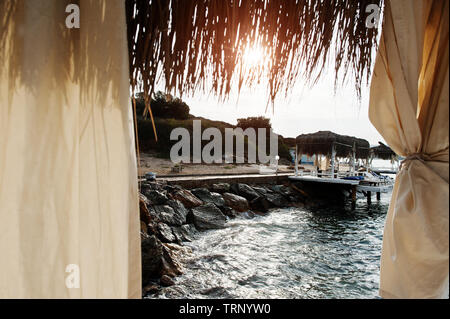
[0,0,141,298]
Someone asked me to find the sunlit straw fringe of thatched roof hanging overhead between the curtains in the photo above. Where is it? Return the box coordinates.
[126,0,383,109]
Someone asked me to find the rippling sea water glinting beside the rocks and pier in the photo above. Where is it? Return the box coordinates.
[154,194,390,298]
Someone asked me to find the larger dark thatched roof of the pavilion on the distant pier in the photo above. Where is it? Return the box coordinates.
[295,131,370,159]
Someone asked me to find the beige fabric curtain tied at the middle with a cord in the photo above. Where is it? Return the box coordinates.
[369,0,449,298]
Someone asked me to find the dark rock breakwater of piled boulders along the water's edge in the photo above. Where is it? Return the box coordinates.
[140,182,318,295]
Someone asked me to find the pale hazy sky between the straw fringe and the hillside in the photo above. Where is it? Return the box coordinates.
[179,72,384,145]
